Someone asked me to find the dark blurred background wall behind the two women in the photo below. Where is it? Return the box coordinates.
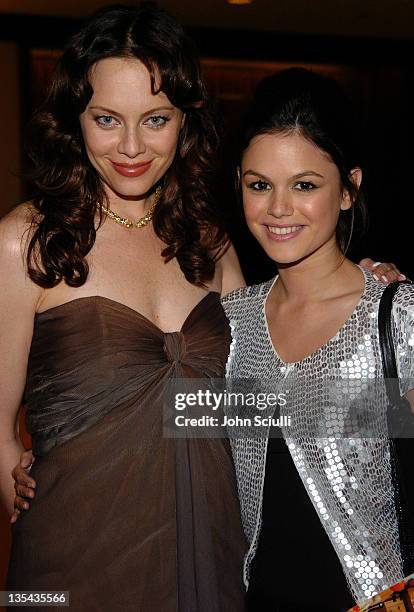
[0,0,414,604]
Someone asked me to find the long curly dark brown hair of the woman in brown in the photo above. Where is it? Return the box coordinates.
[27,3,227,288]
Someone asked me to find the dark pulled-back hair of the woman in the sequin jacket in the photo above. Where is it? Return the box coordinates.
[239,68,367,253]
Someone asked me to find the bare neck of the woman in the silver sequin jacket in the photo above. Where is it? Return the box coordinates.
[275,242,360,304]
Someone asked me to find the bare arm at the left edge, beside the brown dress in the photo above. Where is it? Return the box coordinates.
[0,205,42,516]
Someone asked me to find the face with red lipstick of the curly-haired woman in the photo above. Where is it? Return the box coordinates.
[80,58,183,201]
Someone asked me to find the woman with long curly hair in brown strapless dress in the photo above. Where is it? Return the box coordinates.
[0,5,245,612]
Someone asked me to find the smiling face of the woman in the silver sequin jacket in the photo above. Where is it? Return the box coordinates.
[241,133,360,264]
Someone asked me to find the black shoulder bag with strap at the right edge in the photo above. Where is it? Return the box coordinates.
[378,281,414,576]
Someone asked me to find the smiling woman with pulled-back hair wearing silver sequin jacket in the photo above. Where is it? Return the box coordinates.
[223,69,414,612]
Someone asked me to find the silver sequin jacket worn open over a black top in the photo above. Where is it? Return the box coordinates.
[223,272,414,601]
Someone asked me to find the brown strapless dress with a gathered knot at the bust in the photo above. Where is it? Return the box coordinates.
[7,292,246,612]
